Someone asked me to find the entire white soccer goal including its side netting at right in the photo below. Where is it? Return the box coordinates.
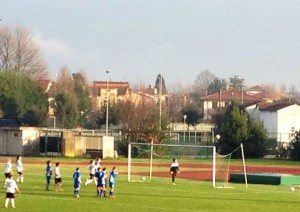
[127,143,246,188]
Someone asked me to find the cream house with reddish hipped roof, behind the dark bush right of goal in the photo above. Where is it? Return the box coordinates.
[200,89,263,119]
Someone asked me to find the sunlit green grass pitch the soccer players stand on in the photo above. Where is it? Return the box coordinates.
[0,158,300,212]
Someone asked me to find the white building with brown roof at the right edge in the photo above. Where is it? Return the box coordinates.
[246,103,300,144]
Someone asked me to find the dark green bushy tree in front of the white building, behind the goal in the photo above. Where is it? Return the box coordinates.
[215,101,267,158]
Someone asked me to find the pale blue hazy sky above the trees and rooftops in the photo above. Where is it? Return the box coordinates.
[0,0,300,88]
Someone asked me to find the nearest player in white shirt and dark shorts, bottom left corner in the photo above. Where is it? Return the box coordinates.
[4,174,21,208]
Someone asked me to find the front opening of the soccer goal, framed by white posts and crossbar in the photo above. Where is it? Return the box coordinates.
[128,142,214,182]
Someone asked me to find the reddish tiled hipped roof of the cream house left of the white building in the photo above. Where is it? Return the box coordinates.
[201,90,262,102]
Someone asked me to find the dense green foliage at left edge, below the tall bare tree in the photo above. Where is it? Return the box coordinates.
[0,70,48,126]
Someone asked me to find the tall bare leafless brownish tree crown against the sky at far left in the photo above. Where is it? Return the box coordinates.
[0,26,47,80]
